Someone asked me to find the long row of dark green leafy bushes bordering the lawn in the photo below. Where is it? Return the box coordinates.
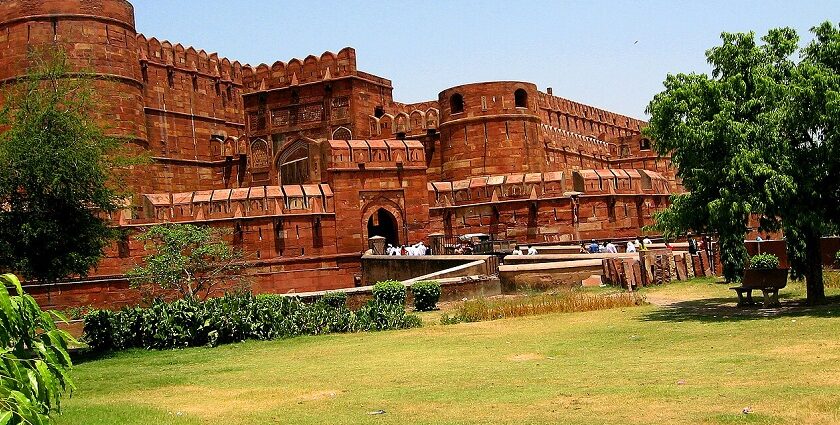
[84,292,420,352]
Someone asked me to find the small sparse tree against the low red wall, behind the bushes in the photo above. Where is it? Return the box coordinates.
[128,224,247,299]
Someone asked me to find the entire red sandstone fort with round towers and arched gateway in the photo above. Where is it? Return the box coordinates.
[0,0,678,305]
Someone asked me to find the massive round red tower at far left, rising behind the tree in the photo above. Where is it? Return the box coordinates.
[0,0,147,145]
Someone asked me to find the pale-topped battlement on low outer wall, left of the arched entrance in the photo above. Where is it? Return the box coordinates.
[135,184,335,225]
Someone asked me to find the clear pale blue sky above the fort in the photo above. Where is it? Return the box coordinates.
[131,0,840,119]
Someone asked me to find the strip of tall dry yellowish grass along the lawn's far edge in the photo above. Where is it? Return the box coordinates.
[441,290,646,324]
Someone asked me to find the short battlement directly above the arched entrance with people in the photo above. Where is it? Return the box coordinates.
[329,140,426,171]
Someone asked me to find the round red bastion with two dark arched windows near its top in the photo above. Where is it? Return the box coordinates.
[438,81,545,181]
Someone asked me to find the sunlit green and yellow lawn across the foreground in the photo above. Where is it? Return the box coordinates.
[58,280,840,425]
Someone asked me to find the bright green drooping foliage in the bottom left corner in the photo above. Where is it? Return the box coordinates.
[0,274,74,425]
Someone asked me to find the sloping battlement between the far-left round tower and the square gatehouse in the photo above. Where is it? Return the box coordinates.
[137,34,250,85]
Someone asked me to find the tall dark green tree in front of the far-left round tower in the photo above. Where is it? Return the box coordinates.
[0,51,131,282]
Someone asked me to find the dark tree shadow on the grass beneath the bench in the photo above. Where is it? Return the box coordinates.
[641,293,840,322]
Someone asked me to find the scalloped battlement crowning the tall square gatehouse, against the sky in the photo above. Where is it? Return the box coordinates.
[242,47,362,91]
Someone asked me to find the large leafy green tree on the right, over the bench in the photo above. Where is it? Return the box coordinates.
[644,23,840,303]
